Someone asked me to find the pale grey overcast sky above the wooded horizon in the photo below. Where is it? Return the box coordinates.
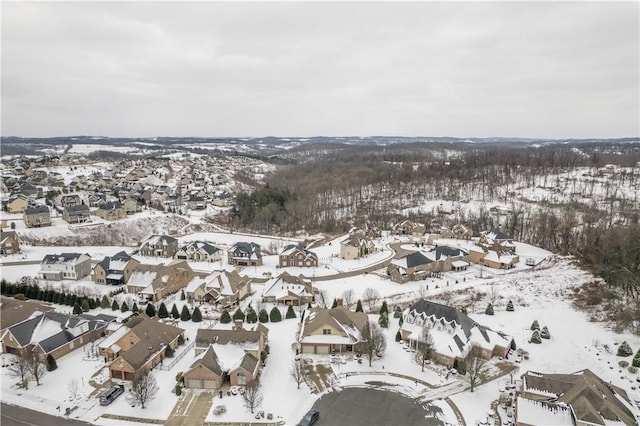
[1,1,640,138]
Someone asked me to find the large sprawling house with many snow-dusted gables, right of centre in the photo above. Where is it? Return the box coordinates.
[400,300,515,368]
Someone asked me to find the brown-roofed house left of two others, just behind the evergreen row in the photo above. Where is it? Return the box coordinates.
[127,260,194,302]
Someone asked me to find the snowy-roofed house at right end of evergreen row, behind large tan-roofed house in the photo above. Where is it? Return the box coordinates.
[262,272,318,306]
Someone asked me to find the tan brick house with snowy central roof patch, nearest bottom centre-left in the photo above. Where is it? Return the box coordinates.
[183,321,269,389]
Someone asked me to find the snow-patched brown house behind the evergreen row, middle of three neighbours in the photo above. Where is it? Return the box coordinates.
[203,270,251,308]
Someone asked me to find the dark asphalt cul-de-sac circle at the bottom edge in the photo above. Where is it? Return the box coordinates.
[313,388,444,426]
